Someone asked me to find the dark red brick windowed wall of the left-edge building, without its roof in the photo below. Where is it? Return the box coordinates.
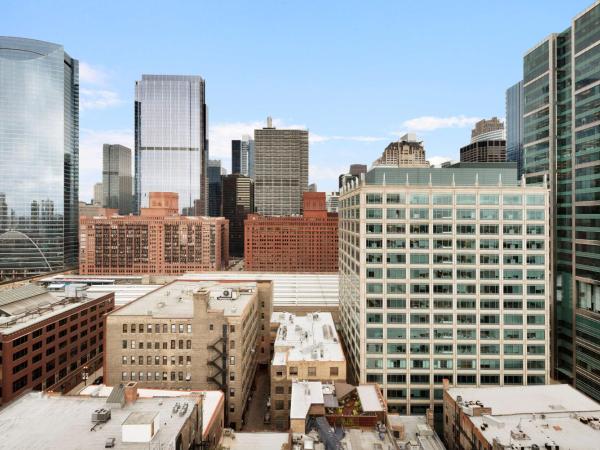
[0,293,114,405]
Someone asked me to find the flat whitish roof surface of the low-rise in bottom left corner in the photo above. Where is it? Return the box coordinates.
[0,391,223,450]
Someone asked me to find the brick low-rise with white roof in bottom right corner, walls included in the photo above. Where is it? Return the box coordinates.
[443,384,600,450]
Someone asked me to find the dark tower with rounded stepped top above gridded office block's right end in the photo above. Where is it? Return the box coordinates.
[460,117,506,163]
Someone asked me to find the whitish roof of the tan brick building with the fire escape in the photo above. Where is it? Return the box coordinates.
[112,280,257,319]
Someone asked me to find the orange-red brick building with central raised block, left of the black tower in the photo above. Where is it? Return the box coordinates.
[79,192,229,275]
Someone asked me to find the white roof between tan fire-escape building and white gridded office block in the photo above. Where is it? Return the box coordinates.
[271,312,345,365]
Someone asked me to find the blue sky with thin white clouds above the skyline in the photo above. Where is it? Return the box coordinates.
[0,0,593,201]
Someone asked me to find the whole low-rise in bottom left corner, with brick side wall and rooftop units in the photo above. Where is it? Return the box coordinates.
[0,383,224,450]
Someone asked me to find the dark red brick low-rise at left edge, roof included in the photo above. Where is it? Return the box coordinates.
[0,285,114,405]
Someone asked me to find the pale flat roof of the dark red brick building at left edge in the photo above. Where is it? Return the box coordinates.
[0,284,107,334]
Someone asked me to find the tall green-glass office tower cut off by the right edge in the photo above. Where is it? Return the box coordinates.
[523,2,600,400]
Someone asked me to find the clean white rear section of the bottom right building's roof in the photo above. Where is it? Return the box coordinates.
[448,384,600,416]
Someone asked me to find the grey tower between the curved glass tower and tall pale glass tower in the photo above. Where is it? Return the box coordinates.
[102,144,133,215]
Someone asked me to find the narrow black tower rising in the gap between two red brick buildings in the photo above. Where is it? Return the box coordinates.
[223,174,254,257]
